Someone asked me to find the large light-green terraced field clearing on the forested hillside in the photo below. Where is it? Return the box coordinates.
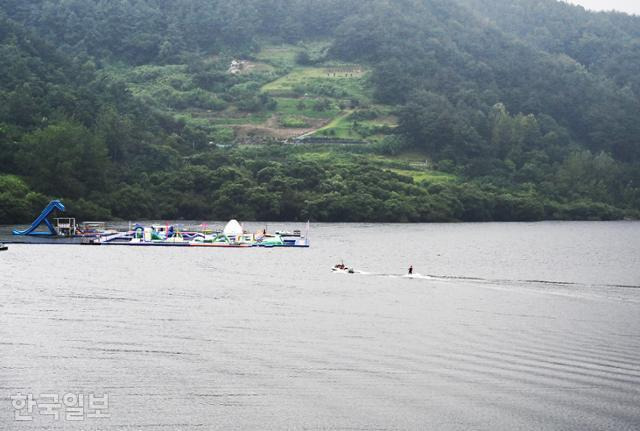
[106,42,395,143]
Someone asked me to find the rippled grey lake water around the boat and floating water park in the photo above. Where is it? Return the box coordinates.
[0,222,640,431]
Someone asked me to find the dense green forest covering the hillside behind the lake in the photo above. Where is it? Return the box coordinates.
[0,0,640,223]
